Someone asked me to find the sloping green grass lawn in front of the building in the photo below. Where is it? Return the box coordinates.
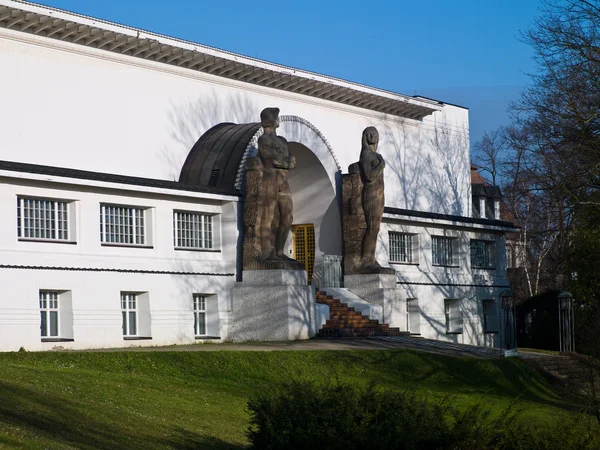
[0,350,578,449]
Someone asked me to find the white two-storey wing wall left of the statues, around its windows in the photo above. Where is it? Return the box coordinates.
[0,178,237,350]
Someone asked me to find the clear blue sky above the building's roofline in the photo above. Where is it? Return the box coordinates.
[39,0,541,142]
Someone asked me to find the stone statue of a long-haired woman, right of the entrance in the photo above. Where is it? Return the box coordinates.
[358,127,391,273]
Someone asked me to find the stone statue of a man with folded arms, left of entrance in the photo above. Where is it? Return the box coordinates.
[258,108,296,262]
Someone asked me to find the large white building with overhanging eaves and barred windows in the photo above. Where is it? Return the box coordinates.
[0,0,513,350]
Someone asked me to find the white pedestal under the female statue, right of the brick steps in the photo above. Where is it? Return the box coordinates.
[344,273,407,331]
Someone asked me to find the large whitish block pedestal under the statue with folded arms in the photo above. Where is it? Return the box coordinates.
[231,269,317,342]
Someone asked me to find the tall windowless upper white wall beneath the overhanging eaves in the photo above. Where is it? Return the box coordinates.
[0,30,470,216]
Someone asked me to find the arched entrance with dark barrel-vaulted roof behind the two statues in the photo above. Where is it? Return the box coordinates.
[179,116,342,286]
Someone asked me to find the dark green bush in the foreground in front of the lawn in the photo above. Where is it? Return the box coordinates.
[248,381,600,450]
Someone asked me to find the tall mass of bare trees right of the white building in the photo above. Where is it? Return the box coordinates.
[474,0,600,412]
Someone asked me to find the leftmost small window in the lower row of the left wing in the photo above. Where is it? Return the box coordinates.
[38,290,73,341]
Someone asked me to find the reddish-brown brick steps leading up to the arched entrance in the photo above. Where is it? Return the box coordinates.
[317,291,409,337]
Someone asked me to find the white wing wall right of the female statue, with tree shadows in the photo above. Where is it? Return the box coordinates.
[377,219,508,347]
